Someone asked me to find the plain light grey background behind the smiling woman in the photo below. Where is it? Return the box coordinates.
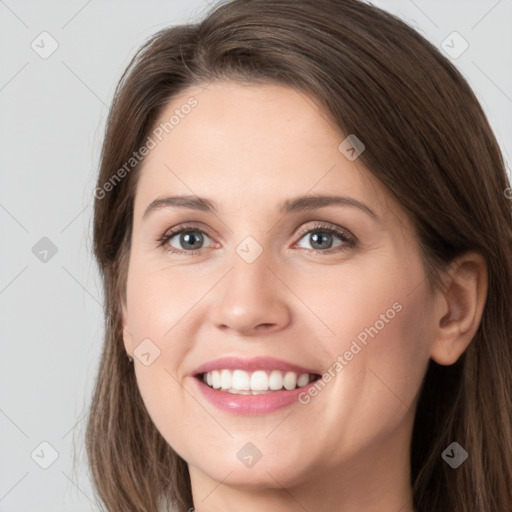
[0,0,512,512]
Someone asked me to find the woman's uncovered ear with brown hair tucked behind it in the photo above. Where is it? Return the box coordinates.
[431,252,488,365]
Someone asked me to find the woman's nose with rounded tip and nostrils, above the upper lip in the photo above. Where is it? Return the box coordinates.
[210,253,291,336]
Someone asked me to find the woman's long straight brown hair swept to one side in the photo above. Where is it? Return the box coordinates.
[86,0,512,512]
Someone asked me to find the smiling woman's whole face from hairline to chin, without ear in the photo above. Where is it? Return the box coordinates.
[123,82,433,488]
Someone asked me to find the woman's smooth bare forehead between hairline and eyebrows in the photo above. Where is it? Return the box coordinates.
[135,82,402,222]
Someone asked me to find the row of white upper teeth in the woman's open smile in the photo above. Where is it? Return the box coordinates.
[203,370,315,395]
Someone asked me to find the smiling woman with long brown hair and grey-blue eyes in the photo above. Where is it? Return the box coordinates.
[87,0,512,512]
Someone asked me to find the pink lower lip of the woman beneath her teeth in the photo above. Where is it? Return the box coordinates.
[193,377,316,415]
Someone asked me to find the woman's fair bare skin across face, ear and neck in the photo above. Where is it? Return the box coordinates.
[123,82,487,512]
